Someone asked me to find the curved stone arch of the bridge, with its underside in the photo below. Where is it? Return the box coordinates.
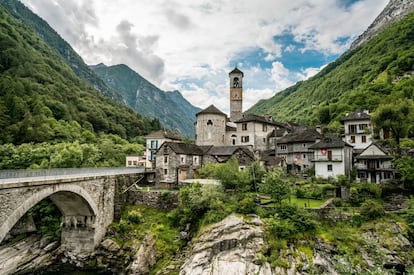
[0,184,98,243]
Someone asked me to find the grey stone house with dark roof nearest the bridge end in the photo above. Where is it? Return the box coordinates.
[155,141,203,185]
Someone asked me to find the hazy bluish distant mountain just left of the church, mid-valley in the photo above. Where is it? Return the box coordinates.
[91,64,201,138]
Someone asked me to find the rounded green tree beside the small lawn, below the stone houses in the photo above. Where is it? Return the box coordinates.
[259,169,291,205]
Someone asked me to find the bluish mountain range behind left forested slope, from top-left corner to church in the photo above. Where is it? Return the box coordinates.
[0,0,199,137]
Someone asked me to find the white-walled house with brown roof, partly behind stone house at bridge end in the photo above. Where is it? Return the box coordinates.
[145,130,181,170]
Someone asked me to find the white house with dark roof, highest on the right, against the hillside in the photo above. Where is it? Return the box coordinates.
[341,110,373,151]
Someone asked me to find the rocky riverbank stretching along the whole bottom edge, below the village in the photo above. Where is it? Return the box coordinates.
[0,214,414,275]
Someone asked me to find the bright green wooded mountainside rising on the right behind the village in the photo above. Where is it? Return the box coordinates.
[246,1,414,126]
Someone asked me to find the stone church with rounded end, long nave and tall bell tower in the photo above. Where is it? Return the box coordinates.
[195,67,283,152]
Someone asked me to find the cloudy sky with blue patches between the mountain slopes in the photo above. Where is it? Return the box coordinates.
[21,0,388,112]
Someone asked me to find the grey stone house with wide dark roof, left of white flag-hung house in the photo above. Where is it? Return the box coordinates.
[276,127,322,176]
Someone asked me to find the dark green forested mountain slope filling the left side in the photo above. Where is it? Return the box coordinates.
[0,5,157,144]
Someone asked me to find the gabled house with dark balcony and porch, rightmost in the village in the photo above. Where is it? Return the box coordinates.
[354,143,395,184]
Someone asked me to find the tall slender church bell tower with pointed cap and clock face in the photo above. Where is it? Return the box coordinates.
[229,67,244,122]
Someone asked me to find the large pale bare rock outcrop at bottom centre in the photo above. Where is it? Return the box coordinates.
[180,214,272,275]
